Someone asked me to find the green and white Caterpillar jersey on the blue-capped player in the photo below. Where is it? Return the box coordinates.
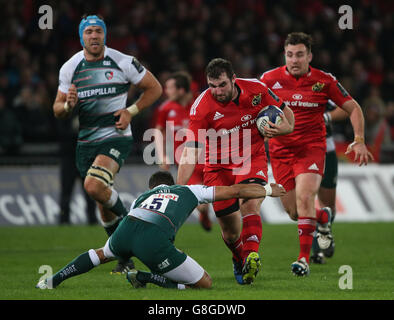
[59,47,146,143]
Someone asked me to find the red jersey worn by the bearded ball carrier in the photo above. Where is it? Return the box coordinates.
[188,78,284,170]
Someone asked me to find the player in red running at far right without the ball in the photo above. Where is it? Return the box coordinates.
[260,32,373,276]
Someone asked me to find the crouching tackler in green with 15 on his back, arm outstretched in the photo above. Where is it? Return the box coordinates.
[36,171,285,289]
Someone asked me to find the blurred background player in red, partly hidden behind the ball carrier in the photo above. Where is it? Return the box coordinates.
[155,71,212,231]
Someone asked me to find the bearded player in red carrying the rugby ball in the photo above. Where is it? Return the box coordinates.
[177,58,294,284]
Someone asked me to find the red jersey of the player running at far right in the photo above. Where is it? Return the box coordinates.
[260,66,352,154]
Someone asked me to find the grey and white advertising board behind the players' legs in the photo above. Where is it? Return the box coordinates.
[0,164,394,226]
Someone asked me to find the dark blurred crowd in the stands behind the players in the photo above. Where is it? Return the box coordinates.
[0,0,394,163]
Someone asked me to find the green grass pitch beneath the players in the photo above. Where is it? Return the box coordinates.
[0,223,394,300]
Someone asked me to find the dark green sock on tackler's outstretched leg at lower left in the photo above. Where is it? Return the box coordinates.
[52,252,94,288]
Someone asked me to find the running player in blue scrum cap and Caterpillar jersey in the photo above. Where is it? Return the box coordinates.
[53,15,162,272]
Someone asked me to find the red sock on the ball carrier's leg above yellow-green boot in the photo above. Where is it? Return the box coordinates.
[241,214,263,259]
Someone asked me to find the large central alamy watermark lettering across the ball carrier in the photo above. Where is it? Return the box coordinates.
[143,120,252,175]
